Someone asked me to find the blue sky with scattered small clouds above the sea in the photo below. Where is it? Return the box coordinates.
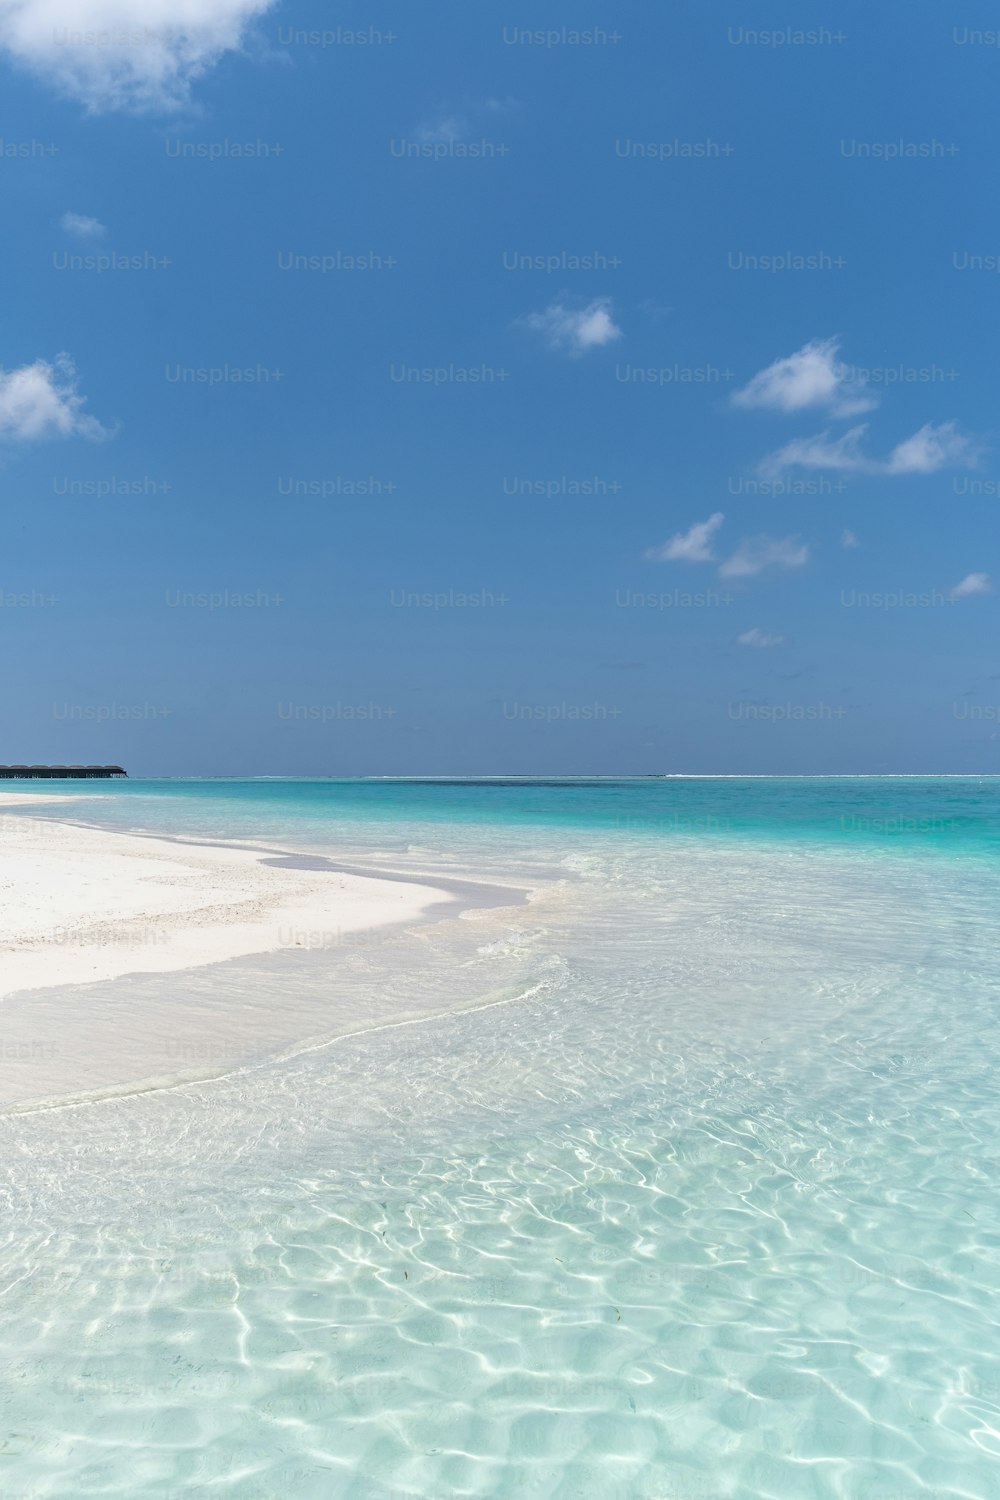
[0,0,1000,776]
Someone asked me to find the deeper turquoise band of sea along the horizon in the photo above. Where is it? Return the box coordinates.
[17,777,1000,849]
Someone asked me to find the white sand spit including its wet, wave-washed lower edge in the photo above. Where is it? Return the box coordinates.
[0,792,500,1109]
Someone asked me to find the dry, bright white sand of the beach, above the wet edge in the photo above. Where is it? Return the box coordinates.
[0,792,447,999]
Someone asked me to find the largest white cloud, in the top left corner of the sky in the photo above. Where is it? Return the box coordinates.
[0,0,273,113]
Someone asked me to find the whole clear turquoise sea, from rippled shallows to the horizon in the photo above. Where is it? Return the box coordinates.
[0,779,1000,1500]
